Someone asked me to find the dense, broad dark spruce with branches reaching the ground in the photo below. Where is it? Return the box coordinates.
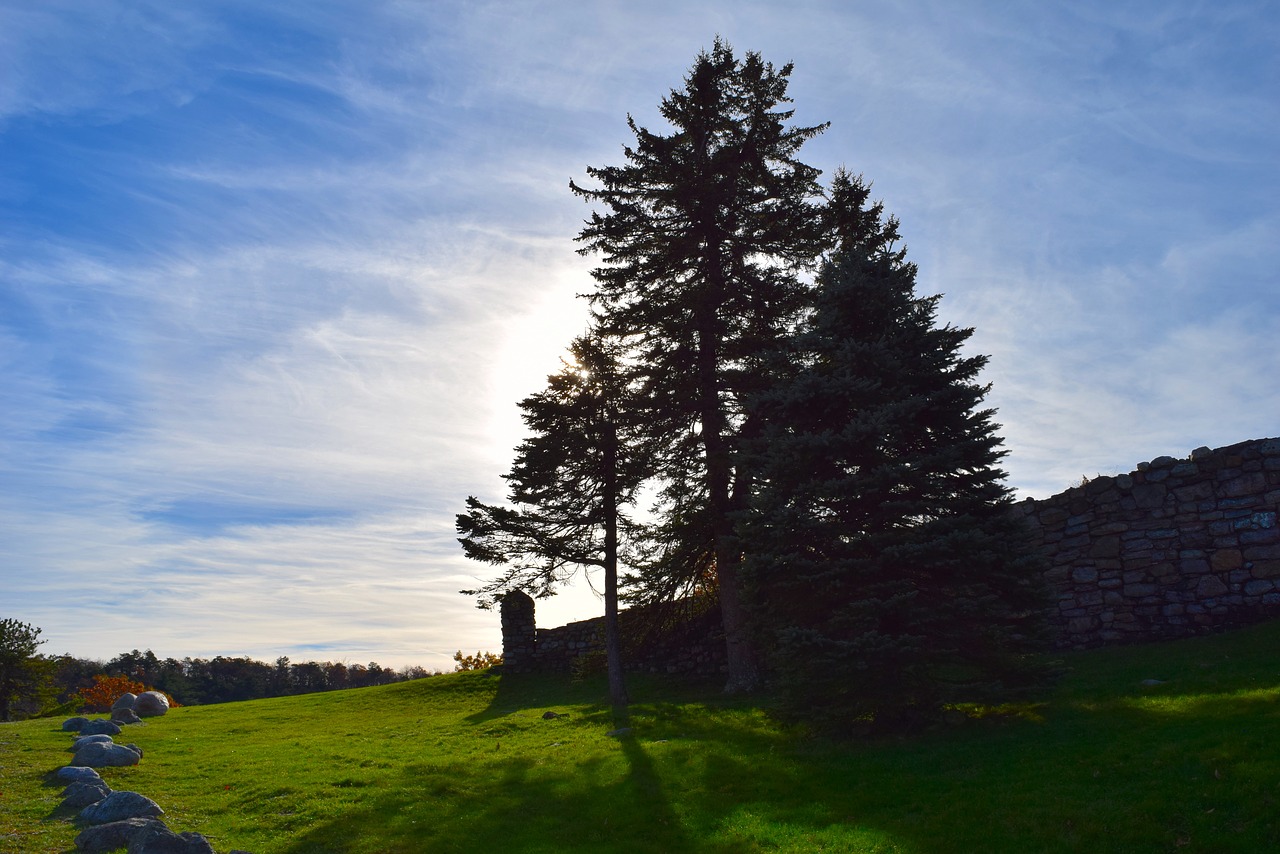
[746,173,1042,727]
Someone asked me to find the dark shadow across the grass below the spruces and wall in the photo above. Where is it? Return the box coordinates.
[257,637,1280,854]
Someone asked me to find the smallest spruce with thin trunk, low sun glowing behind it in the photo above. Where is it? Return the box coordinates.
[457,334,646,708]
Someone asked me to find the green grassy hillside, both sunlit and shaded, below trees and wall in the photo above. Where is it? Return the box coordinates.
[0,622,1280,854]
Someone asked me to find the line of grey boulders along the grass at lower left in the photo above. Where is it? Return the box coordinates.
[54,711,246,854]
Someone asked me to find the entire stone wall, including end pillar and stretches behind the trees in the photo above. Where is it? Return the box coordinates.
[502,439,1280,673]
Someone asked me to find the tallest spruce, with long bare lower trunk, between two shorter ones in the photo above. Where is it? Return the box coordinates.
[571,40,826,690]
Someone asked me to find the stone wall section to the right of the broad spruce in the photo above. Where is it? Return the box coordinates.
[1018,439,1280,648]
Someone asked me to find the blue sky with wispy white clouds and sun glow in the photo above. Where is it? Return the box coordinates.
[0,0,1280,667]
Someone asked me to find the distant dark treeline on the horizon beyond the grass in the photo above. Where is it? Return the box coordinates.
[54,649,442,705]
